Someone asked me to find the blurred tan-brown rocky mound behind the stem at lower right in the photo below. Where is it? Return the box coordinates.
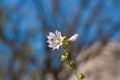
[68,41,120,80]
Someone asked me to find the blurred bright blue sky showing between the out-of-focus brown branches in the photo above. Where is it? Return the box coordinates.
[0,0,120,73]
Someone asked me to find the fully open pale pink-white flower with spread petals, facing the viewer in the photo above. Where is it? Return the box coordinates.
[47,30,63,50]
